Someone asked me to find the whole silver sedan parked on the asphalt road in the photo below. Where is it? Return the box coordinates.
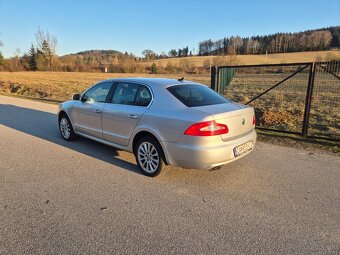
[58,78,256,176]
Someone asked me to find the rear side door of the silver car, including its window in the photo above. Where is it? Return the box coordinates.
[102,82,152,146]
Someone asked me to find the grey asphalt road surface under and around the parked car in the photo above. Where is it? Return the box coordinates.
[0,96,340,254]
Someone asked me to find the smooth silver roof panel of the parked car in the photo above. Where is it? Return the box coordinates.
[99,78,197,87]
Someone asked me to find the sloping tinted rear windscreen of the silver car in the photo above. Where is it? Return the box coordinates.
[167,84,229,107]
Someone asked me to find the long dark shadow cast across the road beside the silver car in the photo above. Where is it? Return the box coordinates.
[0,104,141,174]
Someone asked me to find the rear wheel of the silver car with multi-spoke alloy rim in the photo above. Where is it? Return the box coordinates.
[134,136,165,177]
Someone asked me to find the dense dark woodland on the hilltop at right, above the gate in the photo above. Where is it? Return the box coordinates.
[198,26,340,56]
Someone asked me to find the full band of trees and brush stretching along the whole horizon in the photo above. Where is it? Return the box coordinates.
[0,26,340,73]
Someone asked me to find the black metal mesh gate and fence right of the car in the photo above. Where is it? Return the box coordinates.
[211,61,340,140]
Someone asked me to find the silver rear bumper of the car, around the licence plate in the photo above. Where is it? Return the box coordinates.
[162,129,256,170]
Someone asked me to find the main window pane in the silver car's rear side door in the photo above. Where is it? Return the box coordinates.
[112,82,139,105]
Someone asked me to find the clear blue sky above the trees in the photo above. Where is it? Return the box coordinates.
[0,0,340,57]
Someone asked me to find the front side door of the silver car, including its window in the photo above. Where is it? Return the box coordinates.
[72,82,112,139]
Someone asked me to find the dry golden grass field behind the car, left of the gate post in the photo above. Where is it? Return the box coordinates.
[0,72,210,101]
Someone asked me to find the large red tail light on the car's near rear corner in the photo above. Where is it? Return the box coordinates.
[184,120,229,136]
